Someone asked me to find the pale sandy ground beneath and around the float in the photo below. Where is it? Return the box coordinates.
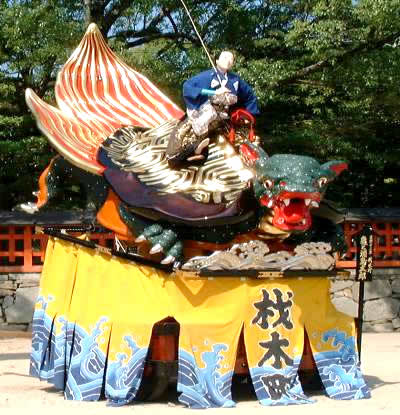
[0,332,400,415]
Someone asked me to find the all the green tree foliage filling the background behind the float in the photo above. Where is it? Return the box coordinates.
[0,0,400,208]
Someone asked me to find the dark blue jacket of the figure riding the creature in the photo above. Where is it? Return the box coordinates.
[183,69,260,115]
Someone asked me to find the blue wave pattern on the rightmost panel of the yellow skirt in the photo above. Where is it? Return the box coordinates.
[314,329,371,400]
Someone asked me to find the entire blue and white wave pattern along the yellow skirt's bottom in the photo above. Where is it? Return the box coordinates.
[30,295,370,408]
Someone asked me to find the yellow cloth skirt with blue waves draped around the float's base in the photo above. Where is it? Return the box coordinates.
[31,239,369,408]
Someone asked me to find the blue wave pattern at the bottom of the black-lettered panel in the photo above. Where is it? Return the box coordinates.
[250,356,314,406]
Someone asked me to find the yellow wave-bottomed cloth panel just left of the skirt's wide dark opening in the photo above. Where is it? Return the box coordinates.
[105,259,170,406]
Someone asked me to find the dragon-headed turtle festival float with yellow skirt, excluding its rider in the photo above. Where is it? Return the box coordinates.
[24,24,370,408]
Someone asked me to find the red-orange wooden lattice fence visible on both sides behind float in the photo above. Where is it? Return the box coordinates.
[0,222,400,273]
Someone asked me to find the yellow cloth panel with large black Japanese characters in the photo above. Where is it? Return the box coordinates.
[244,279,312,405]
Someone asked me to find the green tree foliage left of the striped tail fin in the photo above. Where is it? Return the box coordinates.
[0,0,83,209]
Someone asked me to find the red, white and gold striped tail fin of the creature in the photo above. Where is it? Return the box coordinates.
[26,23,183,174]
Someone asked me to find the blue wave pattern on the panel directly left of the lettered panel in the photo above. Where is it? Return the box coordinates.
[177,343,235,409]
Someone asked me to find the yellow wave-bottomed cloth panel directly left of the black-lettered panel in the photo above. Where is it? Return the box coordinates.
[168,277,245,408]
